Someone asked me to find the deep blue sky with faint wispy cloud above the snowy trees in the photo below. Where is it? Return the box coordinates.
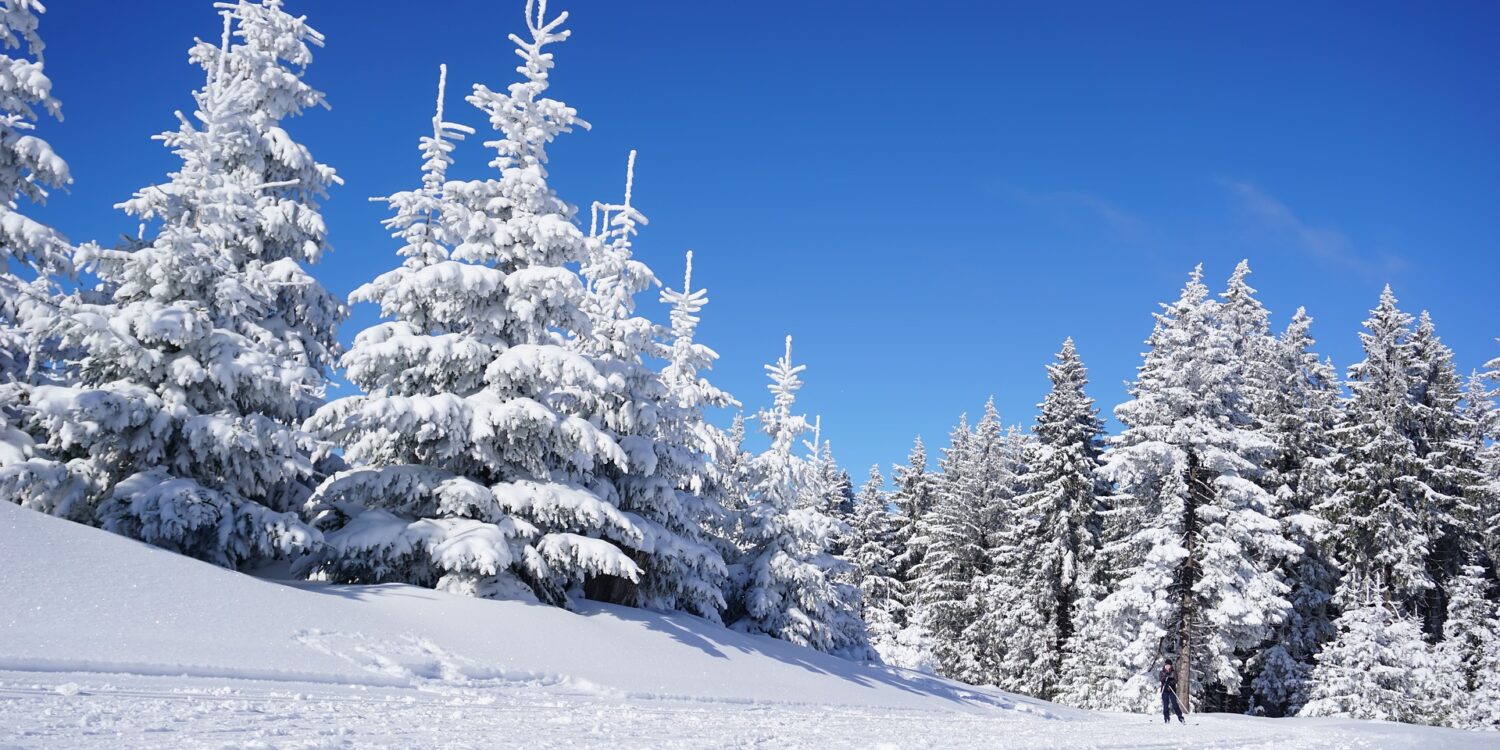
[32,0,1500,480]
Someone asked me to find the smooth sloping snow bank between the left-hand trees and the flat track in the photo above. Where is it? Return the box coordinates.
[0,503,1056,717]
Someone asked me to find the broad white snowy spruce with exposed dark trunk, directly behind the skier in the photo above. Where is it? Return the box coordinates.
[1073,269,1298,710]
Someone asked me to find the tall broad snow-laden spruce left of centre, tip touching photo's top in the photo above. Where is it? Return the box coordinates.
[312,2,654,605]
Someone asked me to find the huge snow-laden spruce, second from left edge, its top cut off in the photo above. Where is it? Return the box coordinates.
[24,0,345,567]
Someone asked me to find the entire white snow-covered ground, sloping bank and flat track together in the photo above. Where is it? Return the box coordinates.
[0,503,1500,749]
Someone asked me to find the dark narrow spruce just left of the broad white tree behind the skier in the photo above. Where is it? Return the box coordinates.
[1002,339,1109,699]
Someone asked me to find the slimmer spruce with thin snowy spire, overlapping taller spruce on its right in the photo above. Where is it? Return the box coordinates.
[303,66,546,594]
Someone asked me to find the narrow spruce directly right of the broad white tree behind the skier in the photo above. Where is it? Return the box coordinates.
[1253,308,1340,716]
